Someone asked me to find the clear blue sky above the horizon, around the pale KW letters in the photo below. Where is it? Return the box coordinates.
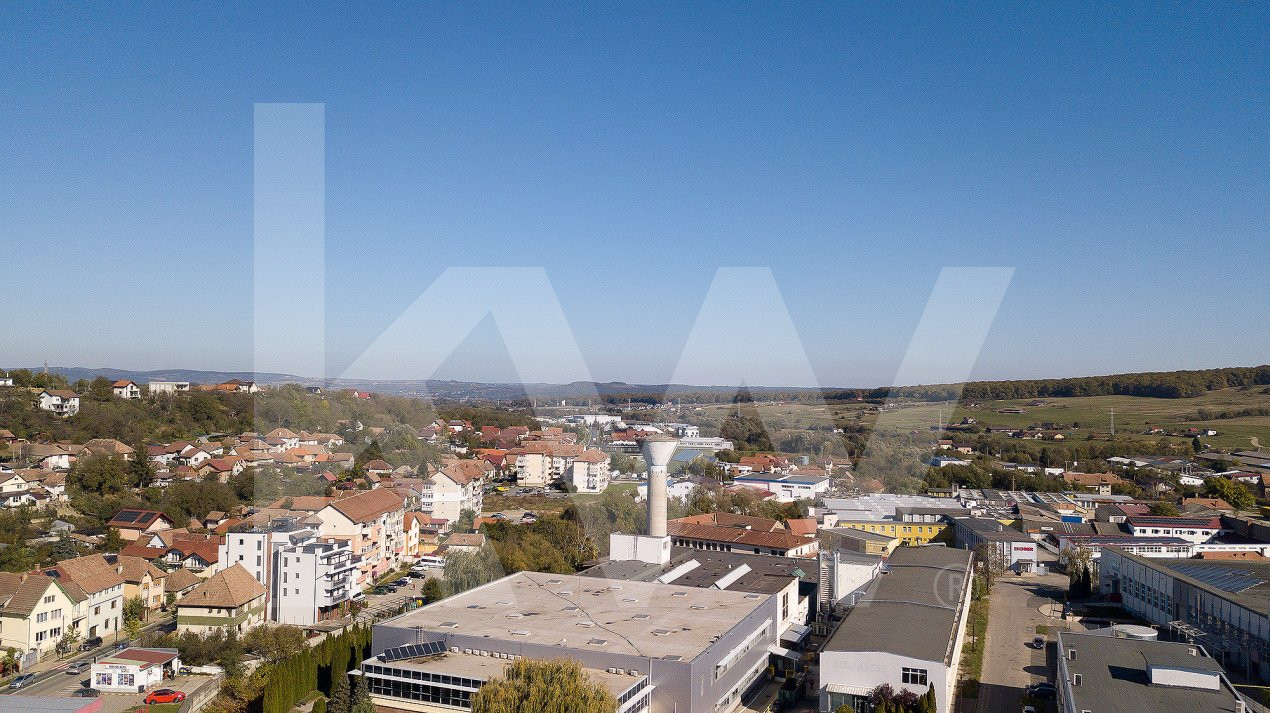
[0,3,1270,385]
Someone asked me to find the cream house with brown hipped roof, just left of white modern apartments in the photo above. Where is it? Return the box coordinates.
[177,564,265,635]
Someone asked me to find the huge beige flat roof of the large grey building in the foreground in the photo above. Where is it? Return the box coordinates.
[380,560,767,660]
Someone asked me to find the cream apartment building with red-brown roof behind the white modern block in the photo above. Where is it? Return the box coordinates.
[315,488,405,586]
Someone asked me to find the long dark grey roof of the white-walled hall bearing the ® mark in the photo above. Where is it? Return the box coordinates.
[824,547,973,661]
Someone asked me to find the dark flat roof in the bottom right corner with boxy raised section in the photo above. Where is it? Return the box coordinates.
[1058,632,1237,713]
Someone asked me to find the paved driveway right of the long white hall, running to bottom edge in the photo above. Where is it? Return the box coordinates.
[977,573,1067,713]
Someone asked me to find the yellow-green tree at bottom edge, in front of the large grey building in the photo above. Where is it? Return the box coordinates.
[472,658,617,713]
